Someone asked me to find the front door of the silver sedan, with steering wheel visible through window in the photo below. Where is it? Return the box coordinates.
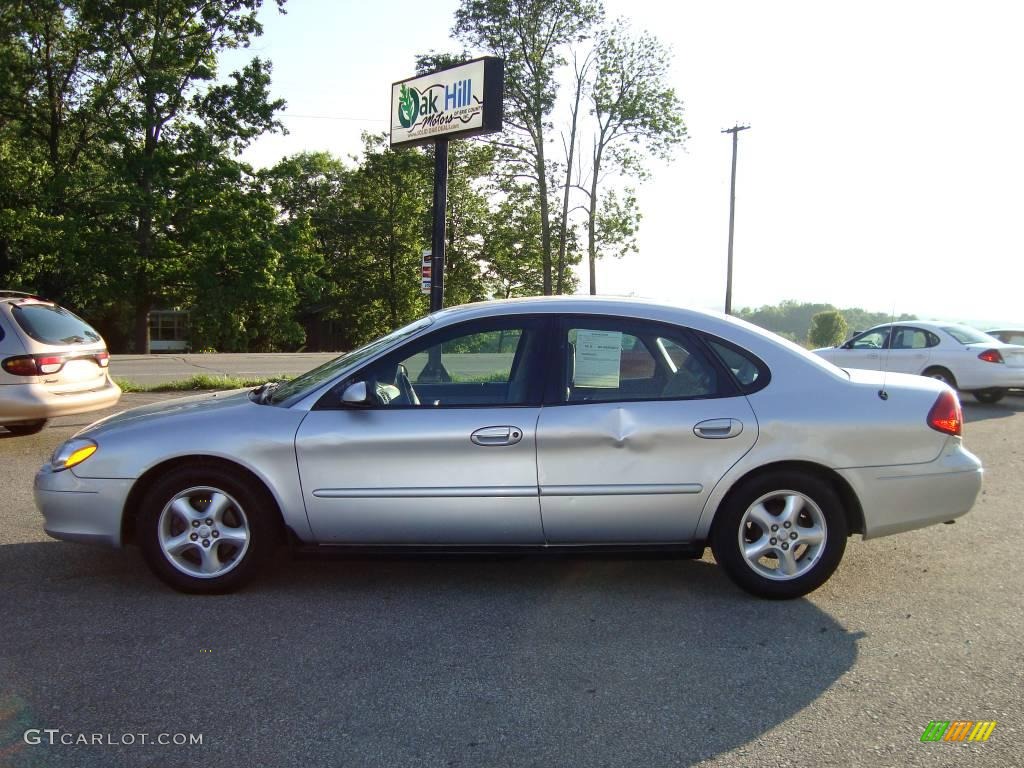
[296,317,546,545]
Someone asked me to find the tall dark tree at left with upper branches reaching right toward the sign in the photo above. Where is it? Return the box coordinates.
[90,0,284,352]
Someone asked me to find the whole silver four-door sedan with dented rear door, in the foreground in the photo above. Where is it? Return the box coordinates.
[35,297,982,598]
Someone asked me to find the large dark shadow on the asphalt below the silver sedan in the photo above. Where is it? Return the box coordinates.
[0,542,858,768]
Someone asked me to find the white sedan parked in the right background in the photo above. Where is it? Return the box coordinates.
[814,321,1024,402]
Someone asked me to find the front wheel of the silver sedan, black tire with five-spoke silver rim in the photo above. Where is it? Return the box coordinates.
[137,466,281,594]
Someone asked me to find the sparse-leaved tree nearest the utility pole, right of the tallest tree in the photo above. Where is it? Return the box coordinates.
[581,19,686,294]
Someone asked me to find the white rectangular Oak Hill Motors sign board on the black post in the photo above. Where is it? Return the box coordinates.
[391,56,505,146]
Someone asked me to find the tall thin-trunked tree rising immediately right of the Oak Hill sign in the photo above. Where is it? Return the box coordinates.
[453,0,602,294]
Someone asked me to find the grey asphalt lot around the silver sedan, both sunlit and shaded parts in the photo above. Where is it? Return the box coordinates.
[0,394,1024,768]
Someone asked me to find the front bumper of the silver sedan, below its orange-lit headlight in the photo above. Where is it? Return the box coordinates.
[34,464,134,548]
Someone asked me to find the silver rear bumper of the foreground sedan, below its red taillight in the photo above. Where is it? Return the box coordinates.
[839,437,983,539]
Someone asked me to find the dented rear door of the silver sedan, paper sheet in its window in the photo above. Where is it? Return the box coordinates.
[538,317,758,544]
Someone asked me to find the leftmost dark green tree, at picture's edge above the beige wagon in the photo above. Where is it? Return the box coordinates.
[0,0,130,306]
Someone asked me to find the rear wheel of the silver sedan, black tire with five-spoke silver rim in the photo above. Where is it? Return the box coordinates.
[711,471,847,600]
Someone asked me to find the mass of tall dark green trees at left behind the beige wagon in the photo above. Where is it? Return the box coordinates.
[0,0,299,351]
